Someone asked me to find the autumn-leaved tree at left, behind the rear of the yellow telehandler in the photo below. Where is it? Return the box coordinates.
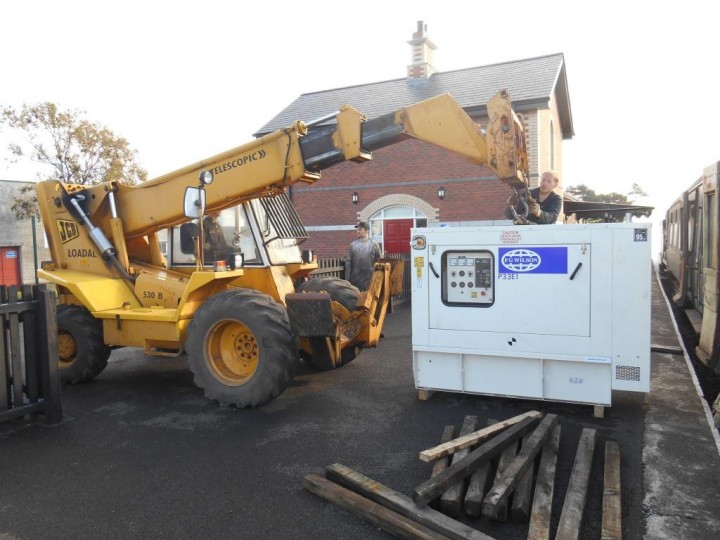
[0,102,147,219]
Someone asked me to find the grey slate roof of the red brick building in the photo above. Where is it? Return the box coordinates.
[255,53,574,139]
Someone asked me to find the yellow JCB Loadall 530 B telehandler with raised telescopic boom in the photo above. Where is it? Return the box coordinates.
[37,91,527,407]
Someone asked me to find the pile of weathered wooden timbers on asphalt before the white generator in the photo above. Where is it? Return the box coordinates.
[304,411,622,540]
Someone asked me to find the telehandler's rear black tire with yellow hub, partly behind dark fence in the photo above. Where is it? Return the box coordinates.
[57,304,110,384]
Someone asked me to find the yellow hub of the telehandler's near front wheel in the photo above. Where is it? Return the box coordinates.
[205,321,260,386]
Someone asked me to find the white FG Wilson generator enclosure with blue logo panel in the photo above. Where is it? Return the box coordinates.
[410,223,652,406]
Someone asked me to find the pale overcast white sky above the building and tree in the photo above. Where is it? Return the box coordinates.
[0,0,720,249]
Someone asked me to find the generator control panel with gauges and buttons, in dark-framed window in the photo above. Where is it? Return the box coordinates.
[442,250,495,307]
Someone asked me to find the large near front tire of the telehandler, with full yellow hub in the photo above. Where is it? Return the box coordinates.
[185,289,298,407]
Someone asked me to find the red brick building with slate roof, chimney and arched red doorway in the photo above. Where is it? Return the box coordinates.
[255,22,573,257]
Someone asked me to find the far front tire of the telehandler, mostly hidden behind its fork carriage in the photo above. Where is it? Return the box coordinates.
[299,277,360,371]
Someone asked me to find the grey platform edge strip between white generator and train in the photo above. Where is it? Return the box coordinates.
[642,272,720,539]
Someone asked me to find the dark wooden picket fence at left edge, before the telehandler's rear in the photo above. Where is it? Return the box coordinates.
[0,285,62,424]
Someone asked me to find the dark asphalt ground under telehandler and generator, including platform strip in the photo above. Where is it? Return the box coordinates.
[0,270,720,540]
